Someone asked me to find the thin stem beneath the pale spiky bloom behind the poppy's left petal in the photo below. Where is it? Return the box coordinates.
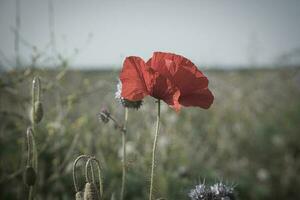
[120,108,128,200]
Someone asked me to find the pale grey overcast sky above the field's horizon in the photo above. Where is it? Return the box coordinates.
[0,0,300,67]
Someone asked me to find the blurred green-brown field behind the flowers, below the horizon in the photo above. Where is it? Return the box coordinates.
[0,68,300,200]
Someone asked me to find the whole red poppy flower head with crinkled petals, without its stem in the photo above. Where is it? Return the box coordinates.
[120,52,214,111]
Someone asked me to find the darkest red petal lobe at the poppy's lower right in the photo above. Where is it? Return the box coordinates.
[179,89,214,109]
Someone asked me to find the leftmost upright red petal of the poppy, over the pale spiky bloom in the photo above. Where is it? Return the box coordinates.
[120,56,149,101]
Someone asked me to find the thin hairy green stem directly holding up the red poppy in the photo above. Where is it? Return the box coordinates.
[149,100,160,200]
